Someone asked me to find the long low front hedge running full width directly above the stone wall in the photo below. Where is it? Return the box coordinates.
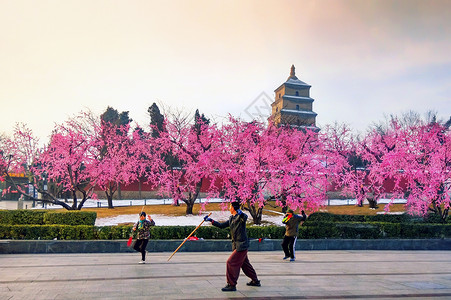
[0,222,451,240]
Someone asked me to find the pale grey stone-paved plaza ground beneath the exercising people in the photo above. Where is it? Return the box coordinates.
[0,251,451,300]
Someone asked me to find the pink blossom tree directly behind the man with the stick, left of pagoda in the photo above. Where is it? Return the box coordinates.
[213,118,279,224]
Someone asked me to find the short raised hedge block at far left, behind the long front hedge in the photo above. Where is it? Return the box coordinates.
[0,209,97,226]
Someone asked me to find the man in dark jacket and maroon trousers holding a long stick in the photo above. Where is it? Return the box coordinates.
[204,202,261,292]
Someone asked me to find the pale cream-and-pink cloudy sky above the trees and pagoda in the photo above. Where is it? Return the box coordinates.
[0,0,451,141]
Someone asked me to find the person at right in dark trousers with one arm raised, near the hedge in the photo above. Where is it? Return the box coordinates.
[282,209,307,261]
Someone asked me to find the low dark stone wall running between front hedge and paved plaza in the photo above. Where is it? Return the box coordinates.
[0,239,451,254]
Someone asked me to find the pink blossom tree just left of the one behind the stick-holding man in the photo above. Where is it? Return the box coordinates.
[154,111,219,214]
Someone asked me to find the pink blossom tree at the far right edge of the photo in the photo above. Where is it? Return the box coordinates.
[385,121,451,222]
